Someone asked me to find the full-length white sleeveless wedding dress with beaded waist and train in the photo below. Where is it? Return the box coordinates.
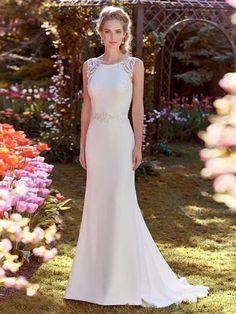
[64,56,209,307]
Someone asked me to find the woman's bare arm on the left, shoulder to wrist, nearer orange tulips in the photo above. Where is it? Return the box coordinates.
[80,61,91,152]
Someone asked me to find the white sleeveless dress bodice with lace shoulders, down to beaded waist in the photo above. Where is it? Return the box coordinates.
[86,56,138,124]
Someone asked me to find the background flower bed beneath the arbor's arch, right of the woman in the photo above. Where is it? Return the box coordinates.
[143,94,217,154]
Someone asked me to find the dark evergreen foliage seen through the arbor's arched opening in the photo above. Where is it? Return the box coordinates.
[172,23,233,96]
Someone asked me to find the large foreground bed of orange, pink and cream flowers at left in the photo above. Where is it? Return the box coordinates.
[0,124,70,296]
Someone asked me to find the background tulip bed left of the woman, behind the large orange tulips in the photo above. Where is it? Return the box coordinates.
[0,83,82,161]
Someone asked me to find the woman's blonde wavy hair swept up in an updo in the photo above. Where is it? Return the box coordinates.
[96,6,133,55]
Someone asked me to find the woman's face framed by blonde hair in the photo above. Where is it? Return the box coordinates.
[100,20,125,49]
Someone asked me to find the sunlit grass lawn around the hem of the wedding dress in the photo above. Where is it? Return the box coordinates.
[1,144,236,314]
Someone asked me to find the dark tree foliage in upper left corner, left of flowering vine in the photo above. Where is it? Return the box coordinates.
[0,0,55,86]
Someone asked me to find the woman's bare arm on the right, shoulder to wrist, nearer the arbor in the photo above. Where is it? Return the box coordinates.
[132,59,144,149]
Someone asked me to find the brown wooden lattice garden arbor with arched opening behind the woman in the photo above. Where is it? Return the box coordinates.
[78,0,236,107]
